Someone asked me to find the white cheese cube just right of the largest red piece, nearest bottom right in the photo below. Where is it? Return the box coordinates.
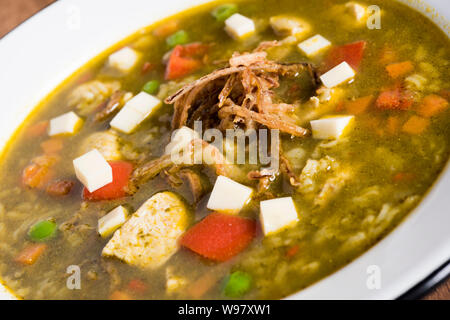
[260,197,298,236]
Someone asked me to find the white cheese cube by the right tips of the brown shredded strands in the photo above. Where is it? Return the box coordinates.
[311,116,355,140]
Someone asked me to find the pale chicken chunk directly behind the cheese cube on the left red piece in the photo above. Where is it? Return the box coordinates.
[79,130,122,160]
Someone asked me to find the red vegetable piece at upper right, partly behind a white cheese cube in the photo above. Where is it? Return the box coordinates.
[325,41,367,70]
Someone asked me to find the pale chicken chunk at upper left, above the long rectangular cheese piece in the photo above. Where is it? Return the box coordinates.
[67,80,121,116]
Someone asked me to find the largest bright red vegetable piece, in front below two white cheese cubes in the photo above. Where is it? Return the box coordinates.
[180,213,256,262]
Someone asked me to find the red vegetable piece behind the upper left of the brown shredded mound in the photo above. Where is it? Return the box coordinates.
[165,43,209,80]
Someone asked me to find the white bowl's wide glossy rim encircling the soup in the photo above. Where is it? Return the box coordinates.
[0,0,450,299]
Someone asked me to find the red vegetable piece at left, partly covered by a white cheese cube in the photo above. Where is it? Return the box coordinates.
[83,161,133,201]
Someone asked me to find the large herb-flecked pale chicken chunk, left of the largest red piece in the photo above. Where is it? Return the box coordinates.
[102,192,190,269]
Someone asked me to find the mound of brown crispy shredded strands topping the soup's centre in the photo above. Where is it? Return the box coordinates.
[165,41,319,133]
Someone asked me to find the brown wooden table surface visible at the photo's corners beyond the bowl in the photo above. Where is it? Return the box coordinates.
[0,0,450,300]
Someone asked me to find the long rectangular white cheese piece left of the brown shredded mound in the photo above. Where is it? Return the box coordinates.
[110,92,162,133]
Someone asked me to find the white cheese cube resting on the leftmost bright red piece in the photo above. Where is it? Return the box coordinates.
[73,149,112,192]
